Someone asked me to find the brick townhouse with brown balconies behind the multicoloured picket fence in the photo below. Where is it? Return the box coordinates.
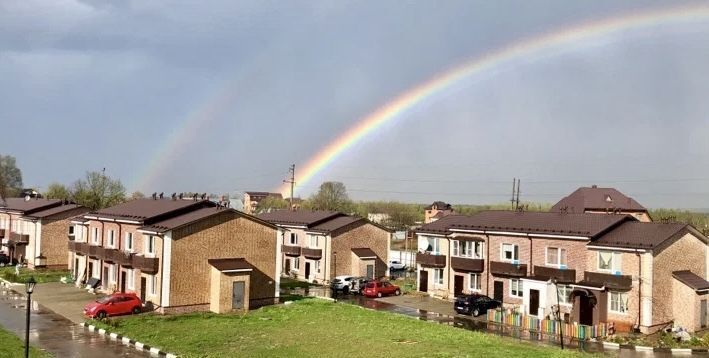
[417,211,709,332]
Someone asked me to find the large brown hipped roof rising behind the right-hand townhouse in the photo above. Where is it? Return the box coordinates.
[549,185,647,213]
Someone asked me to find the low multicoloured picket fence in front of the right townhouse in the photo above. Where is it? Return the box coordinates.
[487,310,608,341]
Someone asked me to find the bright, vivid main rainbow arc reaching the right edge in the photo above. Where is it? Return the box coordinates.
[276,5,709,195]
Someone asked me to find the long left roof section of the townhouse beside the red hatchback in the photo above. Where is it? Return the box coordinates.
[87,198,216,222]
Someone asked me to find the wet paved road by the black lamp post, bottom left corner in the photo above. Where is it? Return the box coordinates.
[0,286,150,358]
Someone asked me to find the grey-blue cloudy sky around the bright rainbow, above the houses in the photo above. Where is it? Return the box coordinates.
[0,0,709,208]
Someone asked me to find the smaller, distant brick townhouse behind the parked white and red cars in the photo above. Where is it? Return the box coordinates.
[258,210,392,283]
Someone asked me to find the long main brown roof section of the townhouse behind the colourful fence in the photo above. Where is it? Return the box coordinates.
[417,210,624,237]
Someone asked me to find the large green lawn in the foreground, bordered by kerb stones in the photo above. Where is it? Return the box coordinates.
[92,299,579,357]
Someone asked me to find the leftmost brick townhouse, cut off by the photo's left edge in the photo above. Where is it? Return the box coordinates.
[0,197,88,269]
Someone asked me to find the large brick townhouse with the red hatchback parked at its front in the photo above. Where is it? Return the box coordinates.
[65,197,280,313]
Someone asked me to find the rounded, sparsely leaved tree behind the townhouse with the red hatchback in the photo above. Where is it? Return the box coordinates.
[73,172,126,210]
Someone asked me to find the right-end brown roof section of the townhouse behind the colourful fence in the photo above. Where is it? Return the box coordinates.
[591,221,690,249]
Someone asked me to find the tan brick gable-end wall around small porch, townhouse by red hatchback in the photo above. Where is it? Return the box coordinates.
[170,211,278,308]
